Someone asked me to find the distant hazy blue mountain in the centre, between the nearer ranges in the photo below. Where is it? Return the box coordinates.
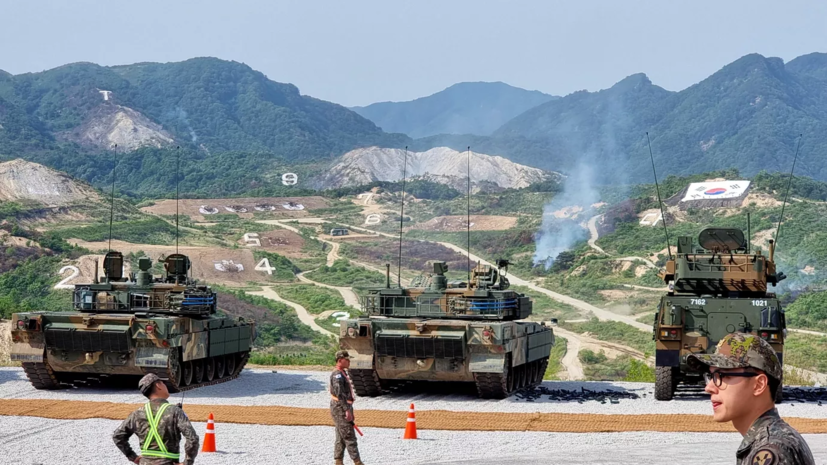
[351,82,557,138]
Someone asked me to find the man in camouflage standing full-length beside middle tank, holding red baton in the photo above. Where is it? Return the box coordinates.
[330,350,364,465]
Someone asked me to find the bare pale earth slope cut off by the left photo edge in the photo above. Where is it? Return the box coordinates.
[0,159,99,206]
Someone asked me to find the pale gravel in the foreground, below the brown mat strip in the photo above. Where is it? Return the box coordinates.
[0,417,827,465]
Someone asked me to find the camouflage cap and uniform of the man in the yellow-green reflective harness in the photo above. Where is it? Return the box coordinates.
[112,375,198,465]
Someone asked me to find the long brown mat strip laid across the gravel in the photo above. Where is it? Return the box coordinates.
[0,399,827,434]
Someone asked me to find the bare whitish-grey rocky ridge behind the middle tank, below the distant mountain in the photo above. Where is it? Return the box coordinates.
[318,147,552,190]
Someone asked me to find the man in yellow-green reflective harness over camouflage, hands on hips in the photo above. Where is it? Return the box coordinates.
[112,373,198,465]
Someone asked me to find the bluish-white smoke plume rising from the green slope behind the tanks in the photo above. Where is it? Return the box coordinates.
[534,164,600,269]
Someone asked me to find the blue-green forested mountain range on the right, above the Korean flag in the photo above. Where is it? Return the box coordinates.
[414,54,827,183]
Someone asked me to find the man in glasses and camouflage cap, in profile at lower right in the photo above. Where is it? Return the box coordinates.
[687,333,815,465]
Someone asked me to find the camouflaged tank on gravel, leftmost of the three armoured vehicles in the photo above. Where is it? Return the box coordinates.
[11,252,255,391]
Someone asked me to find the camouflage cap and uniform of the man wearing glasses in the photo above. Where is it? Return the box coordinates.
[687,333,815,465]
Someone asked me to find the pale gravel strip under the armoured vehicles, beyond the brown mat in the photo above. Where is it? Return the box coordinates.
[0,368,827,418]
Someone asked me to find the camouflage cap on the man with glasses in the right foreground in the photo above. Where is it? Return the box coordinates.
[686,333,784,381]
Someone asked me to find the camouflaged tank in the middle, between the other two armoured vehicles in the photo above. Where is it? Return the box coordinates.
[339,260,554,398]
